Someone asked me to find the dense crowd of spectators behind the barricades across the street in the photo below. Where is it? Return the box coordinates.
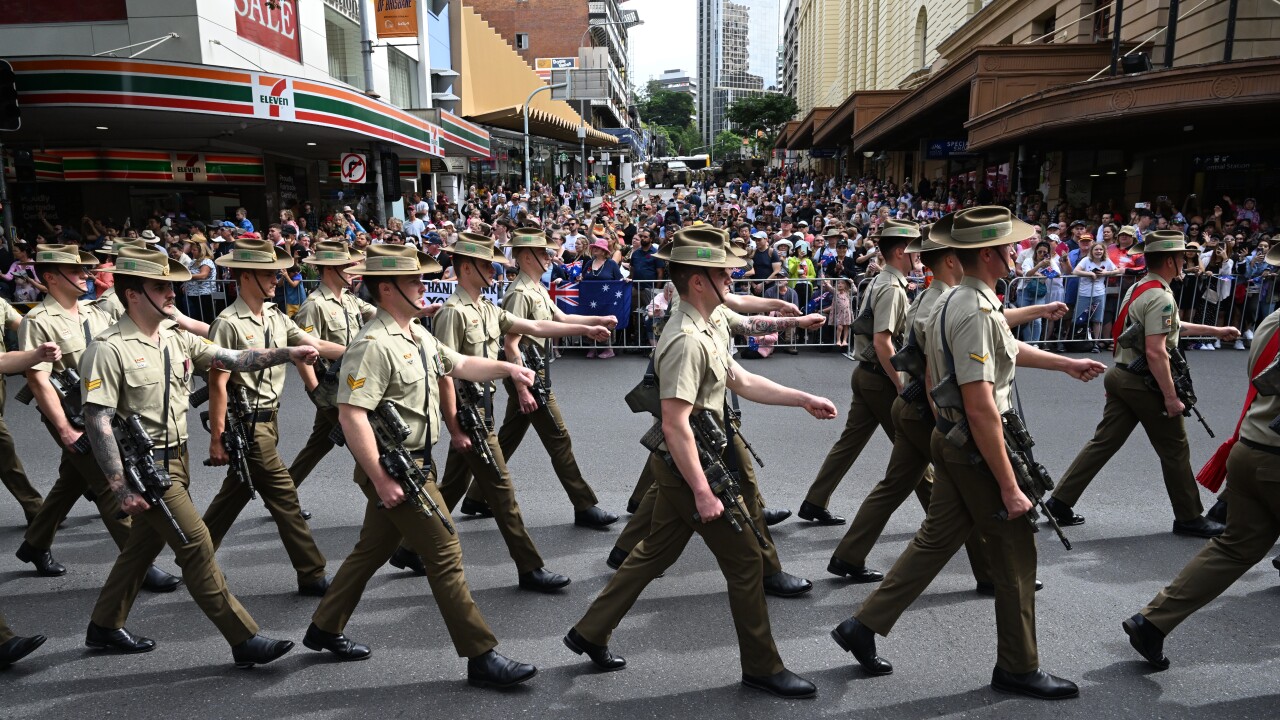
[0,170,1280,357]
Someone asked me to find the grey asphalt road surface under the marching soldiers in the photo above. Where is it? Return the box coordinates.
[0,351,1280,720]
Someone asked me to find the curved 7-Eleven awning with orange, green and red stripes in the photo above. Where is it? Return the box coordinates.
[5,56,465,159]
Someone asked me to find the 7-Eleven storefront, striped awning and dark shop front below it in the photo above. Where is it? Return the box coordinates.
[3,56,489,227]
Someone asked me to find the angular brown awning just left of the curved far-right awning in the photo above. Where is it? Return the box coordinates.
[854,42,1132,150]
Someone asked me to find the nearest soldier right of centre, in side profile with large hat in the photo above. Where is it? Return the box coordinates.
[832,206,1106,700]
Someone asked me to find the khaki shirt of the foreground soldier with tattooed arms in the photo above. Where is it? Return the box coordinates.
[81,315,220,447]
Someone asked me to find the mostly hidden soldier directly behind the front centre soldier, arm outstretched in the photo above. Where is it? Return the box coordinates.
[605,225,826,597]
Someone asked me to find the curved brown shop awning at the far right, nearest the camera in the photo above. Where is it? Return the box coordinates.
[966,58,1280,150]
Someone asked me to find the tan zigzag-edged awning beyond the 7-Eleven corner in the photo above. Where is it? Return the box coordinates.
[460,5,618,147]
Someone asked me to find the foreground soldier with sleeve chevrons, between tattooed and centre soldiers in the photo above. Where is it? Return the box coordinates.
[302,245,536,688]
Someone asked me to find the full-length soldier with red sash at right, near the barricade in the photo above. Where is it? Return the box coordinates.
[1046,231,1240,538]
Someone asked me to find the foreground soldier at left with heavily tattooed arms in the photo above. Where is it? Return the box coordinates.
[81,247,316,667]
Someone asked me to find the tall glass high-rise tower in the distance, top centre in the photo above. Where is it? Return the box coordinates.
[698,0,780,145]
